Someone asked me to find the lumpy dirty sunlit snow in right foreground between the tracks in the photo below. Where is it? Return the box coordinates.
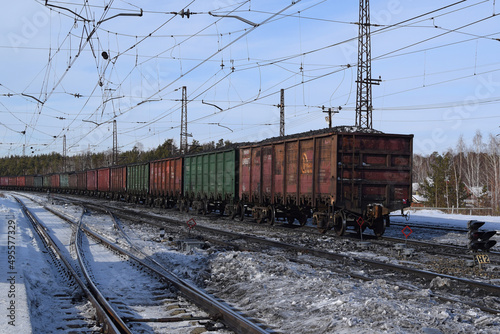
[207,252,500,334]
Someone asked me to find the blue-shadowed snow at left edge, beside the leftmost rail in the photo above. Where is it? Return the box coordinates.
[0,192,96,334]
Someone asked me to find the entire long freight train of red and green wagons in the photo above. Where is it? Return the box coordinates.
[0,128,413,236]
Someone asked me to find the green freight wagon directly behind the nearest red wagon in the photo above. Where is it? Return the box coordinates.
[181,149,238,214]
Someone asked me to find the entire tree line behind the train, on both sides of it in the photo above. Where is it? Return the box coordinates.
[0,131,500,214]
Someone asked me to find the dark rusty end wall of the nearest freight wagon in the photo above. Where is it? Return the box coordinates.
[337,134,413,213]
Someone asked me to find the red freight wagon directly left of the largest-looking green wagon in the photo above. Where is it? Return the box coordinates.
[149,157,183,208]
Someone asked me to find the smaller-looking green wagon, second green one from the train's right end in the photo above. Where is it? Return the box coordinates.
[125,162,151,204]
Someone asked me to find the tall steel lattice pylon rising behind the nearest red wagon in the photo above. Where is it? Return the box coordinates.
[356,0,381,129]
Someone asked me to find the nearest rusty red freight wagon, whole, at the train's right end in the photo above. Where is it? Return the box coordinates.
[239,129,413,235]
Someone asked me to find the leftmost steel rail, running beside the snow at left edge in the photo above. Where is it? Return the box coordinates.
[12,195,122,334]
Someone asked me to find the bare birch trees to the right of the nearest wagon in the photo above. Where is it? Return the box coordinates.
[413,131,500,214]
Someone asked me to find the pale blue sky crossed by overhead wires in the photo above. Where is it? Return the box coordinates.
[0,0,500,156]
